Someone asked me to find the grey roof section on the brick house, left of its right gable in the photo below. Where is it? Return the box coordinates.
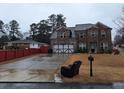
[75,23,97,30]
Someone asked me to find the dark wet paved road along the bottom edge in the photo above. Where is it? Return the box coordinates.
[0,83,124,89]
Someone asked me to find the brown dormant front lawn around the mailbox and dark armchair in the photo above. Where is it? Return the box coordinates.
[62,53,124,83]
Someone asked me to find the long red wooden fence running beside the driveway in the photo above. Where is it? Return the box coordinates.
[0,47,48,62]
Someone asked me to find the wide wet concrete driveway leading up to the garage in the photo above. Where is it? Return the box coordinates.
[0,54,69,82]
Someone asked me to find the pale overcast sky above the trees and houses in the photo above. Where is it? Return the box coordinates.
[0,3,123,38]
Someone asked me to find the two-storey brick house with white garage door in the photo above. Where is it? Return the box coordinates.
[51,22,112,53]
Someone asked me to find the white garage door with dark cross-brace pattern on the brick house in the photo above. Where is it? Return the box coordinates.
[53,45,74,53]
